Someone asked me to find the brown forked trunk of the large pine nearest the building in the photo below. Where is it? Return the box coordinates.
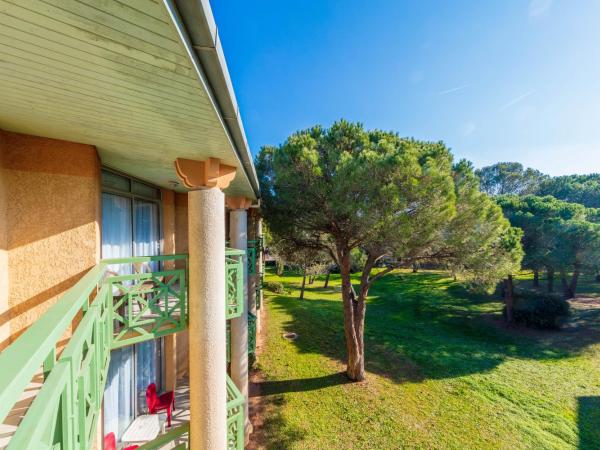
[339,251,365,381]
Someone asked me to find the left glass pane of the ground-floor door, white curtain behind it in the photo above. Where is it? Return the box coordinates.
[104,347,135,440]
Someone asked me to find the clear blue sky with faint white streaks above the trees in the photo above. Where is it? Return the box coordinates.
[211,0,600,175]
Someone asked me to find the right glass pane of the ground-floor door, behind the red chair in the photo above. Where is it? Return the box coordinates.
[135,339,162,414]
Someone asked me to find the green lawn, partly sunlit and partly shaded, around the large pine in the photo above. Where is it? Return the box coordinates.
[253,272,600,449]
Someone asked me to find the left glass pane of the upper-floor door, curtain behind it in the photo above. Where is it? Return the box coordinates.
[102,194,132,275]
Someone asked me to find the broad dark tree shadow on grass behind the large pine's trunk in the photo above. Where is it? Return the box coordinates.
[269,273,600,383]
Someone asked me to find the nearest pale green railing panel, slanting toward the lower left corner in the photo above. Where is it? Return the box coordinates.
[8,286,112,450]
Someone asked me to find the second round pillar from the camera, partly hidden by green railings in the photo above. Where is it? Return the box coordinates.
[229,208,251,439]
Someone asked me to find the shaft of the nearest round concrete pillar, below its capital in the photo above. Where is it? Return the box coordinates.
[188,188,227,450]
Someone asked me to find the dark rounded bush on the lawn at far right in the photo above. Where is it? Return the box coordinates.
[514,291,569,330]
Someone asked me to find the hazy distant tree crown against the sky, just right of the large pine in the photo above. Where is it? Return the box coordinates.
[476,162,548,195]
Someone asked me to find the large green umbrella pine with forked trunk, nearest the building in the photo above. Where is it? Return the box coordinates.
[256,121,522,380]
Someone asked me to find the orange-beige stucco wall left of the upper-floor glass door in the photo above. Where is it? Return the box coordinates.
[0,131,101,349]
